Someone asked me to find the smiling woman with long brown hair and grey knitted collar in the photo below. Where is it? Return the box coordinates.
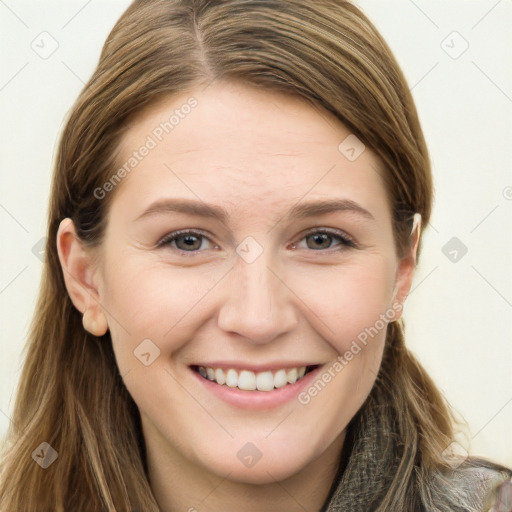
[0,0,511,512]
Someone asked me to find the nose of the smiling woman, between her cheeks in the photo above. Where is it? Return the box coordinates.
[218,247,297,344]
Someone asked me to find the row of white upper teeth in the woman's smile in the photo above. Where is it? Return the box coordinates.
[199,366,306,391]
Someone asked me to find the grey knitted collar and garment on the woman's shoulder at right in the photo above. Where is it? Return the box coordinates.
[320,394,512,512]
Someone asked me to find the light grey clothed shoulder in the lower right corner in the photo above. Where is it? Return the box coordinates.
[426,458,512,512]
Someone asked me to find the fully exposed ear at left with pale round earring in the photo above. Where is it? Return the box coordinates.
[56,218,107,336]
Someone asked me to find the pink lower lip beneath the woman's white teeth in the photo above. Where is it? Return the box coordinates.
[190,366,322,409]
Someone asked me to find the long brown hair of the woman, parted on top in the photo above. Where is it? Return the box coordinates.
[0,0,472,511]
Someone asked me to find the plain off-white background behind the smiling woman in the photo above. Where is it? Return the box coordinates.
[0,0,512,466]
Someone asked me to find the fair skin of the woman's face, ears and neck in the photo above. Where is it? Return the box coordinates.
[57,83,417,512]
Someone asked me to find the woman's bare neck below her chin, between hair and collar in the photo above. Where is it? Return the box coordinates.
[142,418,345,512]
